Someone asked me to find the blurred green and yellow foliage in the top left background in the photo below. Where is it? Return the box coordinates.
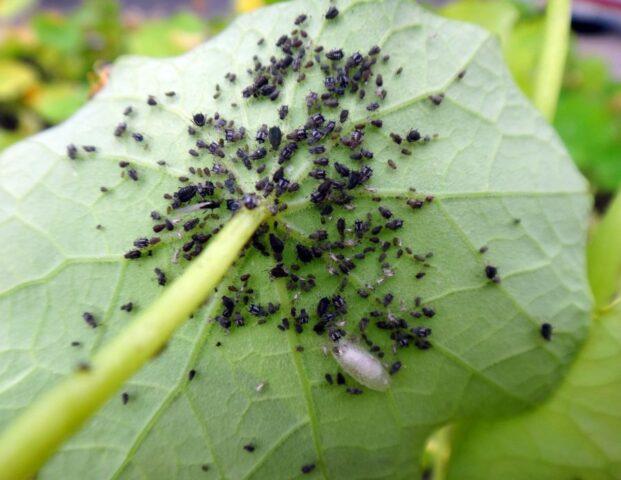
[0,0,226,149]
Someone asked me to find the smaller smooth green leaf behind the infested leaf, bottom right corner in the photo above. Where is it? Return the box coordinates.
[449,307,621,480]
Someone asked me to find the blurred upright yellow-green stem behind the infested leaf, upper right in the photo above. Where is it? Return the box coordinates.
[534,0,571,121]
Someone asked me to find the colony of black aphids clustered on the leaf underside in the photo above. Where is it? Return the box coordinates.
[67,6,552,473]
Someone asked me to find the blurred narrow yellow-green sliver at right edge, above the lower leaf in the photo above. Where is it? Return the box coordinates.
[587,195,621,309]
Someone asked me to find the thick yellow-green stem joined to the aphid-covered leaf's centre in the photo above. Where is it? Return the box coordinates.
[0,207,268,480]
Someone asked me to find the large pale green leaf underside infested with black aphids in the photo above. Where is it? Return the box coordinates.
[0,0,590,478]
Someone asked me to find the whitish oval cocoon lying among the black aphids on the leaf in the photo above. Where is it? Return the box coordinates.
[332,340,390,391]
